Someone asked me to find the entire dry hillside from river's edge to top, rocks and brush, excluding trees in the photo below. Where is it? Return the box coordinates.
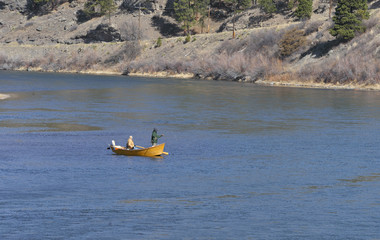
[0,0,380,88]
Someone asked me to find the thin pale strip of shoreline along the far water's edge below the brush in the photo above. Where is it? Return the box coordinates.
[0,68,380,92]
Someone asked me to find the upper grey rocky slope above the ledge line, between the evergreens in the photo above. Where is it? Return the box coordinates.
[0,0,328,45]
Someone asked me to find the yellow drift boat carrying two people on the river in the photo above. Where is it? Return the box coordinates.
[109,141,168,157]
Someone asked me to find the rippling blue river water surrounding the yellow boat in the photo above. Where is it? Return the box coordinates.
[0,71,380,239]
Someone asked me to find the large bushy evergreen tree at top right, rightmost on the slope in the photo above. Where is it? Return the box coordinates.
[330,0,369,41]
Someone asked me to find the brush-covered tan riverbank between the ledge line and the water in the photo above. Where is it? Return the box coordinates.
[0,12,380,90]
